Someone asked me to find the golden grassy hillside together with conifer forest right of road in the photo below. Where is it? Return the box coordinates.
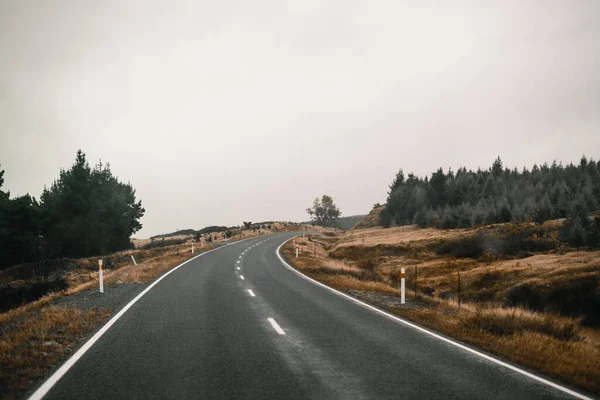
[283,157,600,393]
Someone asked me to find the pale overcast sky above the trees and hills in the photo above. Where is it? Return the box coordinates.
[0,0,600,237]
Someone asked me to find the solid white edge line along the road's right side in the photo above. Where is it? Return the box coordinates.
[271,235,593,400]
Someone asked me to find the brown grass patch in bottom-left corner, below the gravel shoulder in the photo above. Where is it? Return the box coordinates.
[0,306,110,399]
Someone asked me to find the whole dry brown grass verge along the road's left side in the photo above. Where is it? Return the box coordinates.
[0,241,210,398]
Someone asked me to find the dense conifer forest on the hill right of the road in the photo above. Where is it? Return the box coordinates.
[380,156,600,244]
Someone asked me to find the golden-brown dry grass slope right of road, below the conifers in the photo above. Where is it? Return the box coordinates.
[283,226,600,393]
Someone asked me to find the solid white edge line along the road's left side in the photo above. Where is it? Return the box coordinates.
[28,239,255,400]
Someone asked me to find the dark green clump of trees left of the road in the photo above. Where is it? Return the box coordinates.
[0,150,145,271]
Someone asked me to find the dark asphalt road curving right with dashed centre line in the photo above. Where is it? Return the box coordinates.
[36,234,584,400]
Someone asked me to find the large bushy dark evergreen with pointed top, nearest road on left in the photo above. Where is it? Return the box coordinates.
[41,150,144,257]
